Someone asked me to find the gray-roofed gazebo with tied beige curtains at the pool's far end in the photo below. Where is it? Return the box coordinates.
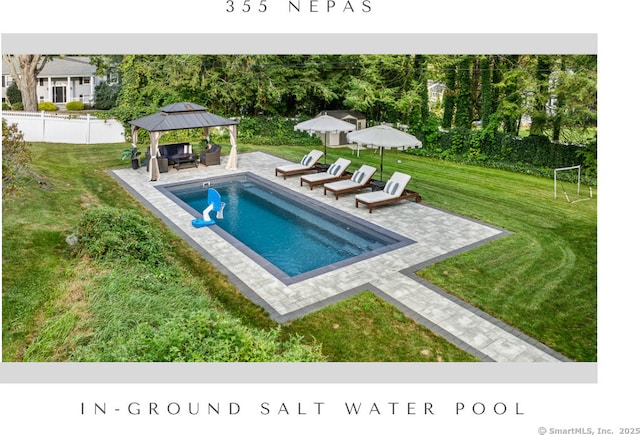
[129,103,238,181]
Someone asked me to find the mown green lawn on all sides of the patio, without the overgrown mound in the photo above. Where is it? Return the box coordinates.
[2,144,597,361]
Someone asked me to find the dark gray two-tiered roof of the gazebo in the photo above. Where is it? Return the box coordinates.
[129,103,238,131]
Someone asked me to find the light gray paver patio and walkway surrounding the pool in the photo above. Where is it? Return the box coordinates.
[112,152,569,362]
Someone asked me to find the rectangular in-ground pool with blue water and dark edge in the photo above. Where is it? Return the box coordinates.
[158,173,413,283]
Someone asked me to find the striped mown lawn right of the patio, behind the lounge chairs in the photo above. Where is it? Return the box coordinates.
[238,143,597,361]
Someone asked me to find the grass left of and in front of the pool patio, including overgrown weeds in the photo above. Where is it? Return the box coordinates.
[2,144,473,361]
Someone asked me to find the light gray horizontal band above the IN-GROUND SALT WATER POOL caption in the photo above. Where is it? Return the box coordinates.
[0,363,597,384]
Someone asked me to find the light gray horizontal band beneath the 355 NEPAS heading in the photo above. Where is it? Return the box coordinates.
[2,33,598,54]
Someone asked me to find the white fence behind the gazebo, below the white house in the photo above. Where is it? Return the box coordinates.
[2,111,125,144]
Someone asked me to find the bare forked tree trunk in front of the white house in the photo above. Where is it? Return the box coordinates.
[2,54,49,112]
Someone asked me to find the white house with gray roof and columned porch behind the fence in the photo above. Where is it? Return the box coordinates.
[2,56,107,107]
